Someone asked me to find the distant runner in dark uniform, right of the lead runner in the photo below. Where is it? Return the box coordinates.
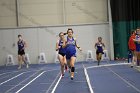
[95,37,105,65]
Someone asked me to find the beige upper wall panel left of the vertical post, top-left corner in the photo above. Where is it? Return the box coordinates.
[0,0,17,28]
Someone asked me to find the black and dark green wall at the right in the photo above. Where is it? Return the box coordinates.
[110,0,140,58]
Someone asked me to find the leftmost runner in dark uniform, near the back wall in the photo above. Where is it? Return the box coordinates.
[17,35,29,69]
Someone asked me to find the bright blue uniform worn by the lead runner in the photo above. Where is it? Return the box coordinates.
[66,37,76,59]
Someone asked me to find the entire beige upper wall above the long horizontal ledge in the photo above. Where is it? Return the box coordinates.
[0,0,108,28]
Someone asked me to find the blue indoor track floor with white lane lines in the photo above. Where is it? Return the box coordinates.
[0,61,140,93]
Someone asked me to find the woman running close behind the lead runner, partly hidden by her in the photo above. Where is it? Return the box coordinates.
[56,32,67,77]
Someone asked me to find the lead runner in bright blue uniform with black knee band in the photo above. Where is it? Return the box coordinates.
[65,28,82,80]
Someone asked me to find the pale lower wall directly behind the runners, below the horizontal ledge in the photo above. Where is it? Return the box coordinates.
[0,23,113,65]
